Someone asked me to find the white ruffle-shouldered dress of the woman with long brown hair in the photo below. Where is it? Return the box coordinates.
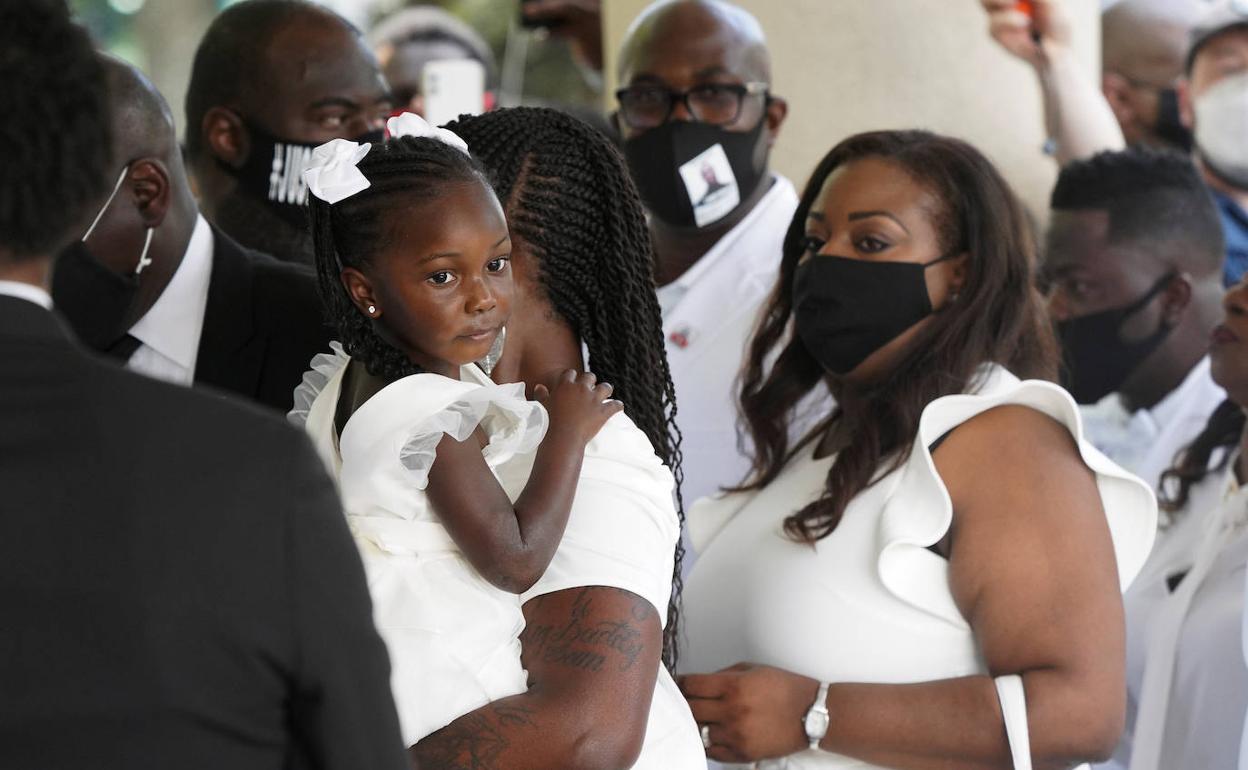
[681,366,1157,770]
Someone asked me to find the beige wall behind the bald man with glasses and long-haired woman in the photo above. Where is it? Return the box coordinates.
[605,0,1099,218]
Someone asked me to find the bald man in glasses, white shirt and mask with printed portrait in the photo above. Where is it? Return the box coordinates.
[615,0,797,502]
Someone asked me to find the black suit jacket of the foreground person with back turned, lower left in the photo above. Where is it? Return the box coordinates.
[0,296,407,770]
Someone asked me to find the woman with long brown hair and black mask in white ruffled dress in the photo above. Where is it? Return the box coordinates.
[681,131,1157,770]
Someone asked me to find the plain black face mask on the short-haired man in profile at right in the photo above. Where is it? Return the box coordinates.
[1057,273,1174,404]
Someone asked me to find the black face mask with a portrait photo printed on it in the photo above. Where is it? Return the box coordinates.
[624,116,766,227]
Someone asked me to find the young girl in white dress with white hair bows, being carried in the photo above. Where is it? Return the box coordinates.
[292,115,622,746]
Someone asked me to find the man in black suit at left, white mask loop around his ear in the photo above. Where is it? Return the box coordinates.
[52,57,328,412]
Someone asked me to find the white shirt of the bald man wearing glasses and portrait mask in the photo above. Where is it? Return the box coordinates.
[659,176,797,505]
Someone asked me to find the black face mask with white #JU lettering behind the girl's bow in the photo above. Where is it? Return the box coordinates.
[221,121,386,230]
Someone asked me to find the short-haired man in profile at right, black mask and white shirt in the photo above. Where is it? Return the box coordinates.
[1045,150,1226,489]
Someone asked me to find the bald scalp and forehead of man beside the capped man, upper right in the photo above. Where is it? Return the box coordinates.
[1101,0,1204,87]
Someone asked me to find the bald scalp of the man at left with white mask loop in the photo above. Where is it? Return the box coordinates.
[101,55,177,162]
